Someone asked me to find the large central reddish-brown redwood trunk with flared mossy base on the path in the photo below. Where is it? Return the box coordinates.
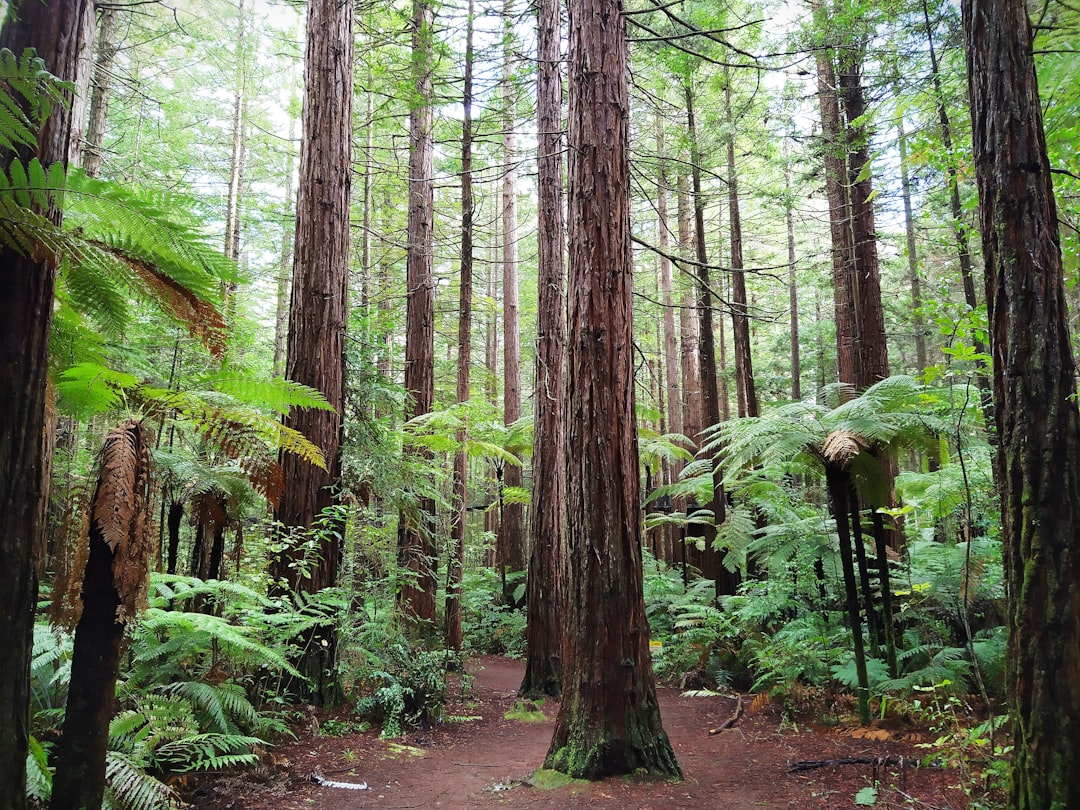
[545,0,680,779]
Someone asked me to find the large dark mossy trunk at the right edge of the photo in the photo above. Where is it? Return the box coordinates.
[962,0,1080,810]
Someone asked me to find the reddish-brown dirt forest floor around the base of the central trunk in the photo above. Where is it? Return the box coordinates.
[181,657,989,810]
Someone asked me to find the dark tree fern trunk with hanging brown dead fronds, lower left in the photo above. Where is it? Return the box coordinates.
[52,421,152,810]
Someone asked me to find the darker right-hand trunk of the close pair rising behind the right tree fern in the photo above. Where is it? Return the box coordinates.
[839,49,889,391]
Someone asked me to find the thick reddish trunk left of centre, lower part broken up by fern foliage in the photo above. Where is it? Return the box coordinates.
[271,0,353,704]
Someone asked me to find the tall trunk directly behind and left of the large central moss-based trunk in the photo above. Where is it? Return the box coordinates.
[521,0,566,696]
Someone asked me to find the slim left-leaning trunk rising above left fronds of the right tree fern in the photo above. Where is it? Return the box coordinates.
[724,68,759,417]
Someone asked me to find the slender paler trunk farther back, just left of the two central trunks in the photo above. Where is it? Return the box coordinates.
[498,0,527,591]
